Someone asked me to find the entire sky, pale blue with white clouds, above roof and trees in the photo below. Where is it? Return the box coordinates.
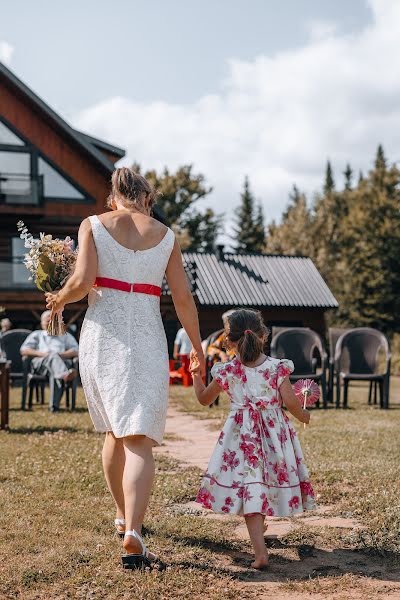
[0,0,400,243]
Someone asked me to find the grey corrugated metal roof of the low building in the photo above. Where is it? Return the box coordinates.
[164,252,338,309]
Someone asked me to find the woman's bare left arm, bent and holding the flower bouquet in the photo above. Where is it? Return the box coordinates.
[46,219,97,312]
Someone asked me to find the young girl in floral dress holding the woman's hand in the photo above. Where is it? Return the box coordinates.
[190,309,315,569]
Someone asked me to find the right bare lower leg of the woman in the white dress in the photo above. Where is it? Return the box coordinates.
[122,435,155,552]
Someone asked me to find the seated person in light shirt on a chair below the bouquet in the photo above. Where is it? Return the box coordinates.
[21,310,78,412]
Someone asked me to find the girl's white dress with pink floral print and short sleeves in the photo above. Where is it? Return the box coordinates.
[196,357,315,517]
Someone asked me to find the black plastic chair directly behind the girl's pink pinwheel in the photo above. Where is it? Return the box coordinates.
[271,327,328,408]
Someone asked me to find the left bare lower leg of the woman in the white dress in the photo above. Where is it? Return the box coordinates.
[102,431,125,531]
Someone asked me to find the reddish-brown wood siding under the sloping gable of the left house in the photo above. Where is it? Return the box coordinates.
[0,81,110,215]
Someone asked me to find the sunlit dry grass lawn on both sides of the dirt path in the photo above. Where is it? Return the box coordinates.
[0,379,400,600]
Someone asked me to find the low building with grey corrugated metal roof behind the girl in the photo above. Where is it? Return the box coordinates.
[163,246,338,347]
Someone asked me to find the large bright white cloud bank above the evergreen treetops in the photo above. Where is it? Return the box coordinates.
[74,0,400,241]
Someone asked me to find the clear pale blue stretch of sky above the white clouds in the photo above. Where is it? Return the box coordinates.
[0,0,371,115]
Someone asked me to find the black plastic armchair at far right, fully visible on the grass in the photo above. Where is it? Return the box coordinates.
[335,327,392,408]
